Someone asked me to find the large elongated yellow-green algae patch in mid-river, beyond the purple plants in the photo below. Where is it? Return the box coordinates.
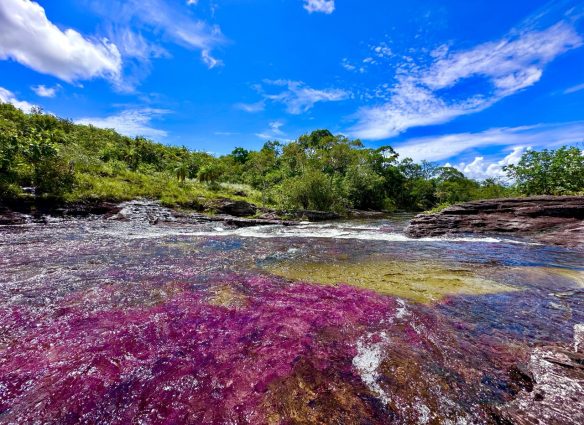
[267,259,515,303]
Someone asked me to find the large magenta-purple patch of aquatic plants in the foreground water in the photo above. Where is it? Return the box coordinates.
[0,278,394,423]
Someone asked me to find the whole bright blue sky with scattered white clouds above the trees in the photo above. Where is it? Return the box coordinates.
[0,0,584,178]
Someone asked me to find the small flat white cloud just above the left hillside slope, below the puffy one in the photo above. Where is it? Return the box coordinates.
[75,108,169,139]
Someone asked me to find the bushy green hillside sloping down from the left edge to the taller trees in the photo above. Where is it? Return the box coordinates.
[0,104,260,208]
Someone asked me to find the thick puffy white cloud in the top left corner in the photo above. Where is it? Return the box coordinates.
[0,0,122,82]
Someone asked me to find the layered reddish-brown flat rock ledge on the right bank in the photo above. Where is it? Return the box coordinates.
[405,196,584,247]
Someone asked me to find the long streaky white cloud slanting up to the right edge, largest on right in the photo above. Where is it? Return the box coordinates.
[350,22,582,140]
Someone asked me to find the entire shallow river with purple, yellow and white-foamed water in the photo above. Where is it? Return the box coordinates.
[0,216,584,424]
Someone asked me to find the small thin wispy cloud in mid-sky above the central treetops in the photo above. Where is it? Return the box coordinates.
[264,80,350,115]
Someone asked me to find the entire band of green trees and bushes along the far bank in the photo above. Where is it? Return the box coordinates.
[0,104,584,212]
